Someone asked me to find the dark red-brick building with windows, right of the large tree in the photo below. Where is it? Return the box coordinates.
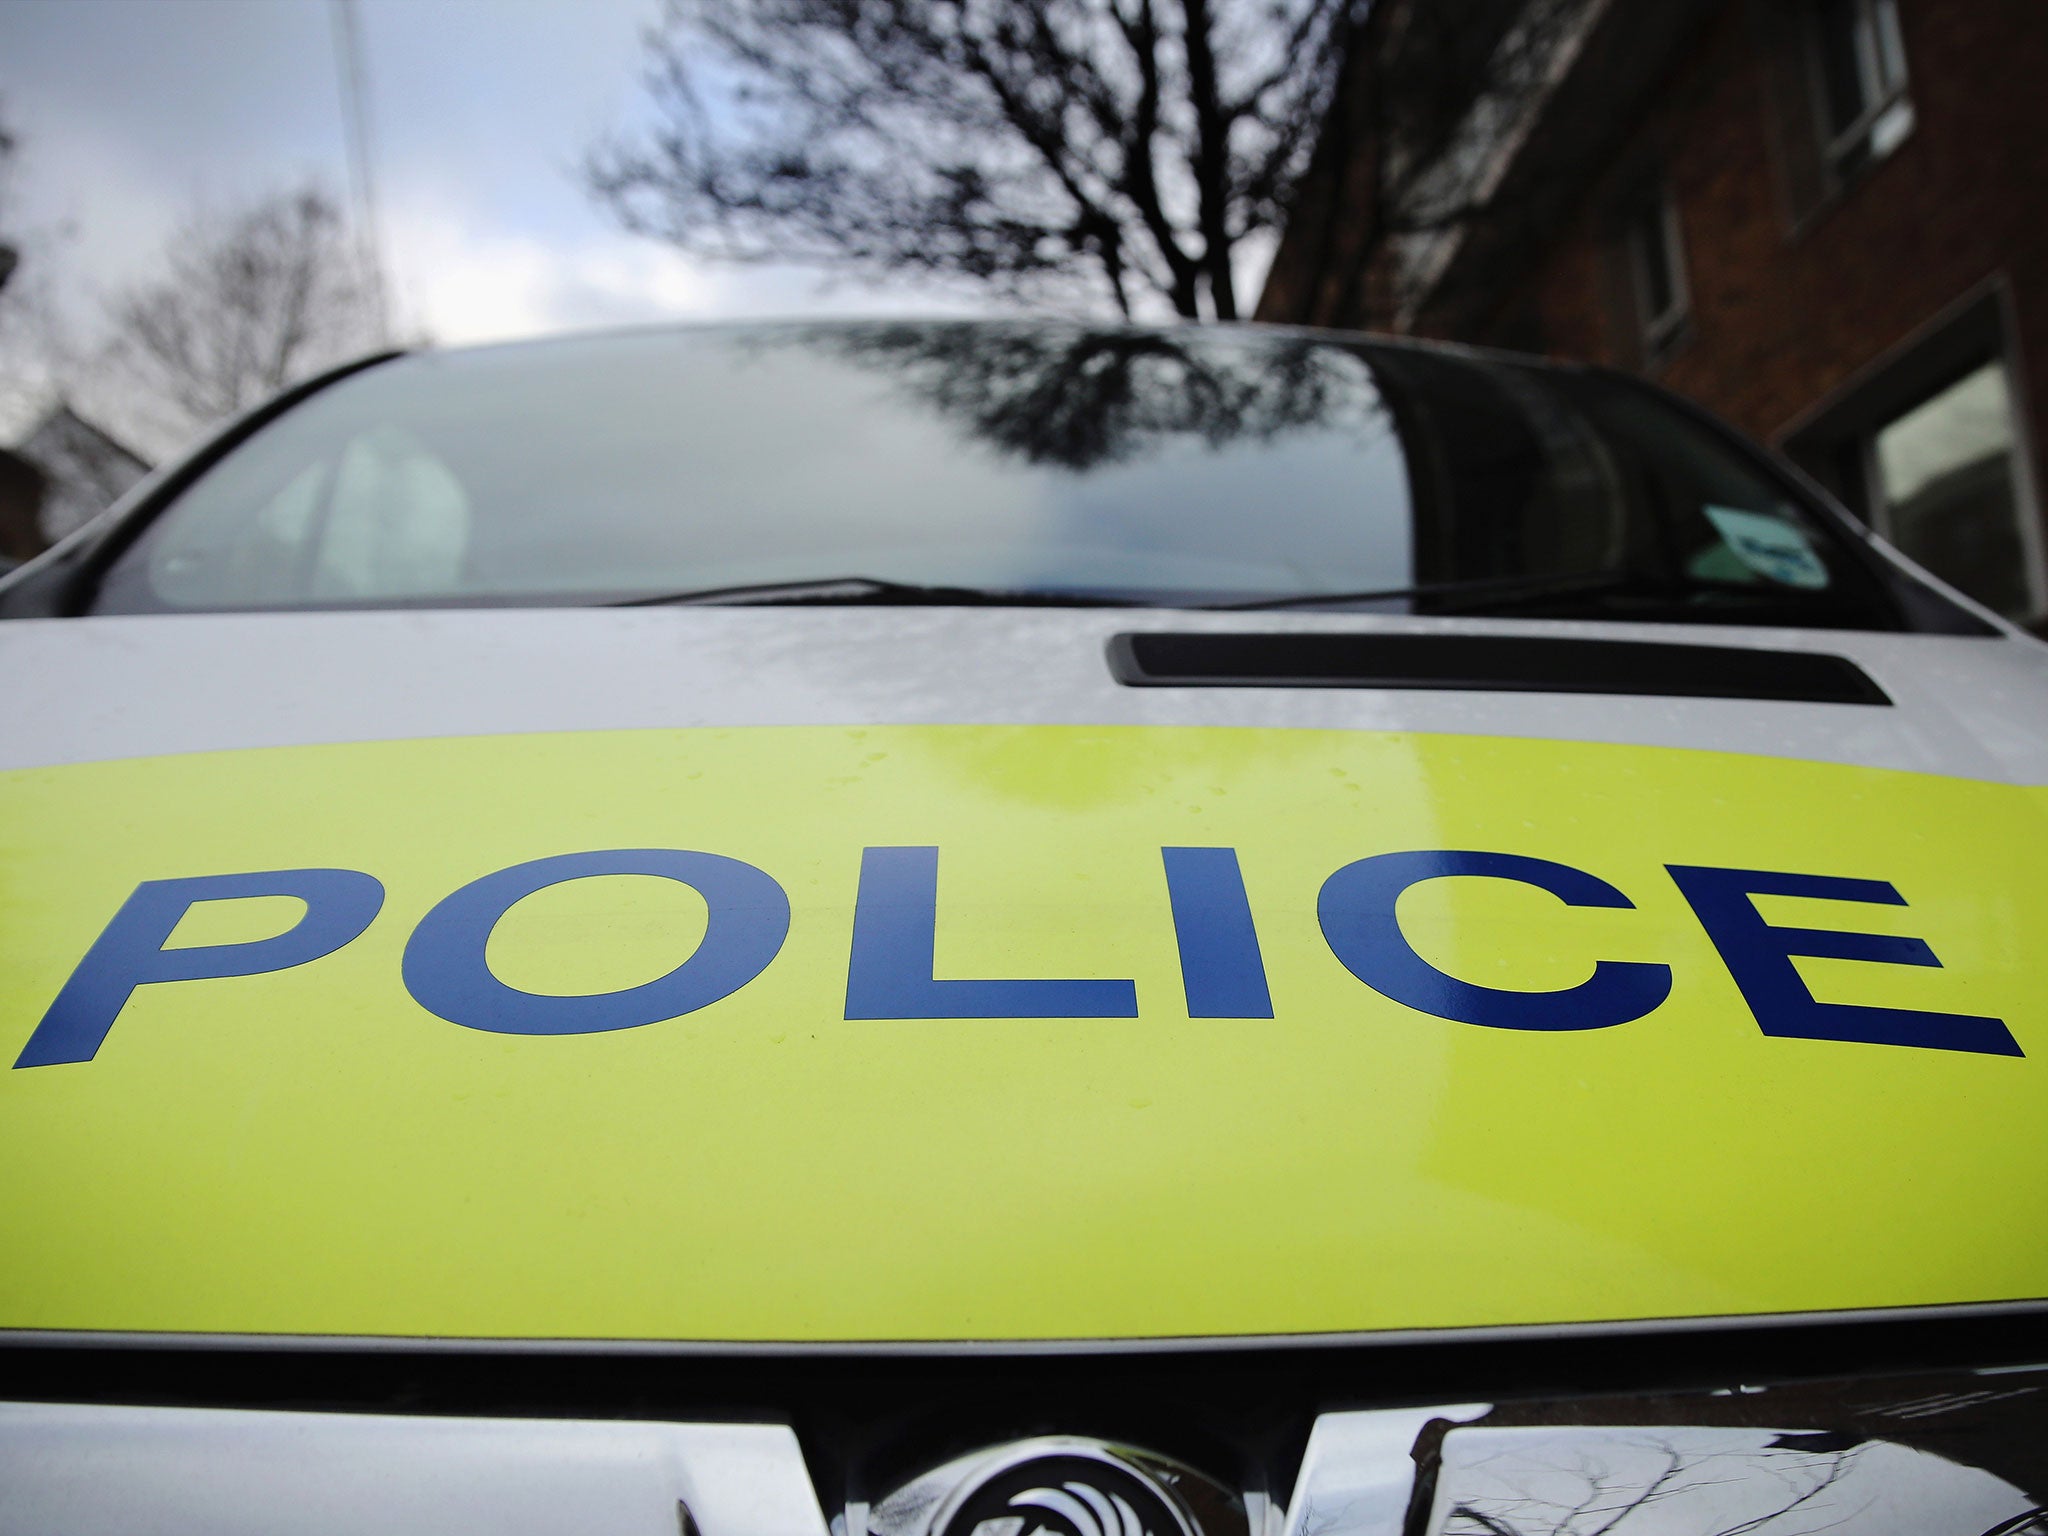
[1257,0,2048,625]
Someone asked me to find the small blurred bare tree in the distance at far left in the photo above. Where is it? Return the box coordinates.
[100,184,381,444]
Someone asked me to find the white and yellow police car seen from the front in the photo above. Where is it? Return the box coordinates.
[0,322,2048,1536]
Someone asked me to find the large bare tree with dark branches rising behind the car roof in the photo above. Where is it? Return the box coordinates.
[588,0,1366,319]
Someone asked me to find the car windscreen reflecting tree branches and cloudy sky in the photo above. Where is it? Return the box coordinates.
[94,324,1896,627]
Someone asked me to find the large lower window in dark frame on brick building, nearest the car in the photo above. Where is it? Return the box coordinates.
[1786,295,2048,623]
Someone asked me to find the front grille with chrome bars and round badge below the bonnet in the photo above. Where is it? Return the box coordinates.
[0,1309,2048,1536]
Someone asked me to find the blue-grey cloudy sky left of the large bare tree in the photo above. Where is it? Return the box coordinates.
[0,0,991,370]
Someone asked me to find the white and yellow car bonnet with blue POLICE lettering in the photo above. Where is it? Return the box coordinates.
[0,608,2048,1341]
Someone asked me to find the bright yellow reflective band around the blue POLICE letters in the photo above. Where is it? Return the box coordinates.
[0,727,2048,1339]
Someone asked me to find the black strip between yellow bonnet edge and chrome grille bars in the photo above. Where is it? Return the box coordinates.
[0,1305,2048,1432]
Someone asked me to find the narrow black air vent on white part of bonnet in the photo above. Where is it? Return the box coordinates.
[1110,633,1892,705]
